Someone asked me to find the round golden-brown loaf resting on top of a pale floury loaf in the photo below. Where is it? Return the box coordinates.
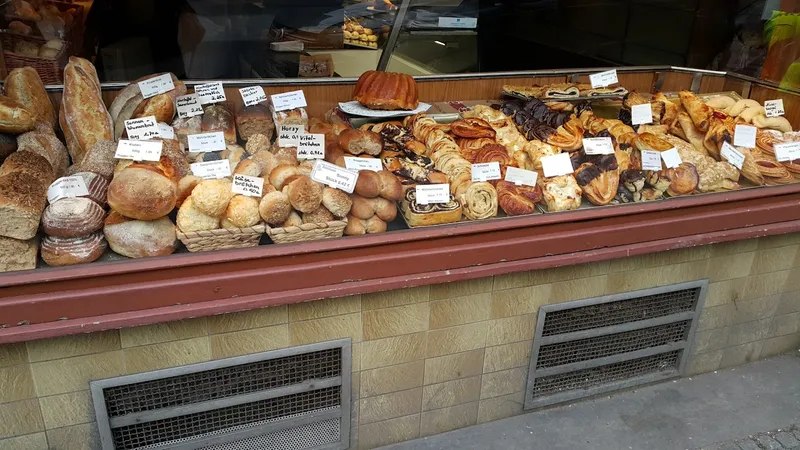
[108,164,178,220]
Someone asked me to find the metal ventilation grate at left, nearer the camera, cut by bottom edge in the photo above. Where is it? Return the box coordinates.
[91,340,351,450]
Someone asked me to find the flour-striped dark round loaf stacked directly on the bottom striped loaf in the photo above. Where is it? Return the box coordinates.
[42,197,106,238]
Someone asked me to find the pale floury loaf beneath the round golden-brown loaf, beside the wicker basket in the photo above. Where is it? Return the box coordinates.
[103,211,178,258]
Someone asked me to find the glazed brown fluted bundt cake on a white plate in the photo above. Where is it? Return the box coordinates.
[353,70,419,111]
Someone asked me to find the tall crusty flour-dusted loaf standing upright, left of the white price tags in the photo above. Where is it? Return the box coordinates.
[62,57,114,161]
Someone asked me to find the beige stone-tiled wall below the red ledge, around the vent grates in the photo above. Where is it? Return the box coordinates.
[0,233,800,450]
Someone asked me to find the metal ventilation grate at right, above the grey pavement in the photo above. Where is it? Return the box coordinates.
[525,280,708,409]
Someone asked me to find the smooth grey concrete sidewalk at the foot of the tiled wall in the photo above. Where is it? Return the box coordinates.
[383,352,800,450]
